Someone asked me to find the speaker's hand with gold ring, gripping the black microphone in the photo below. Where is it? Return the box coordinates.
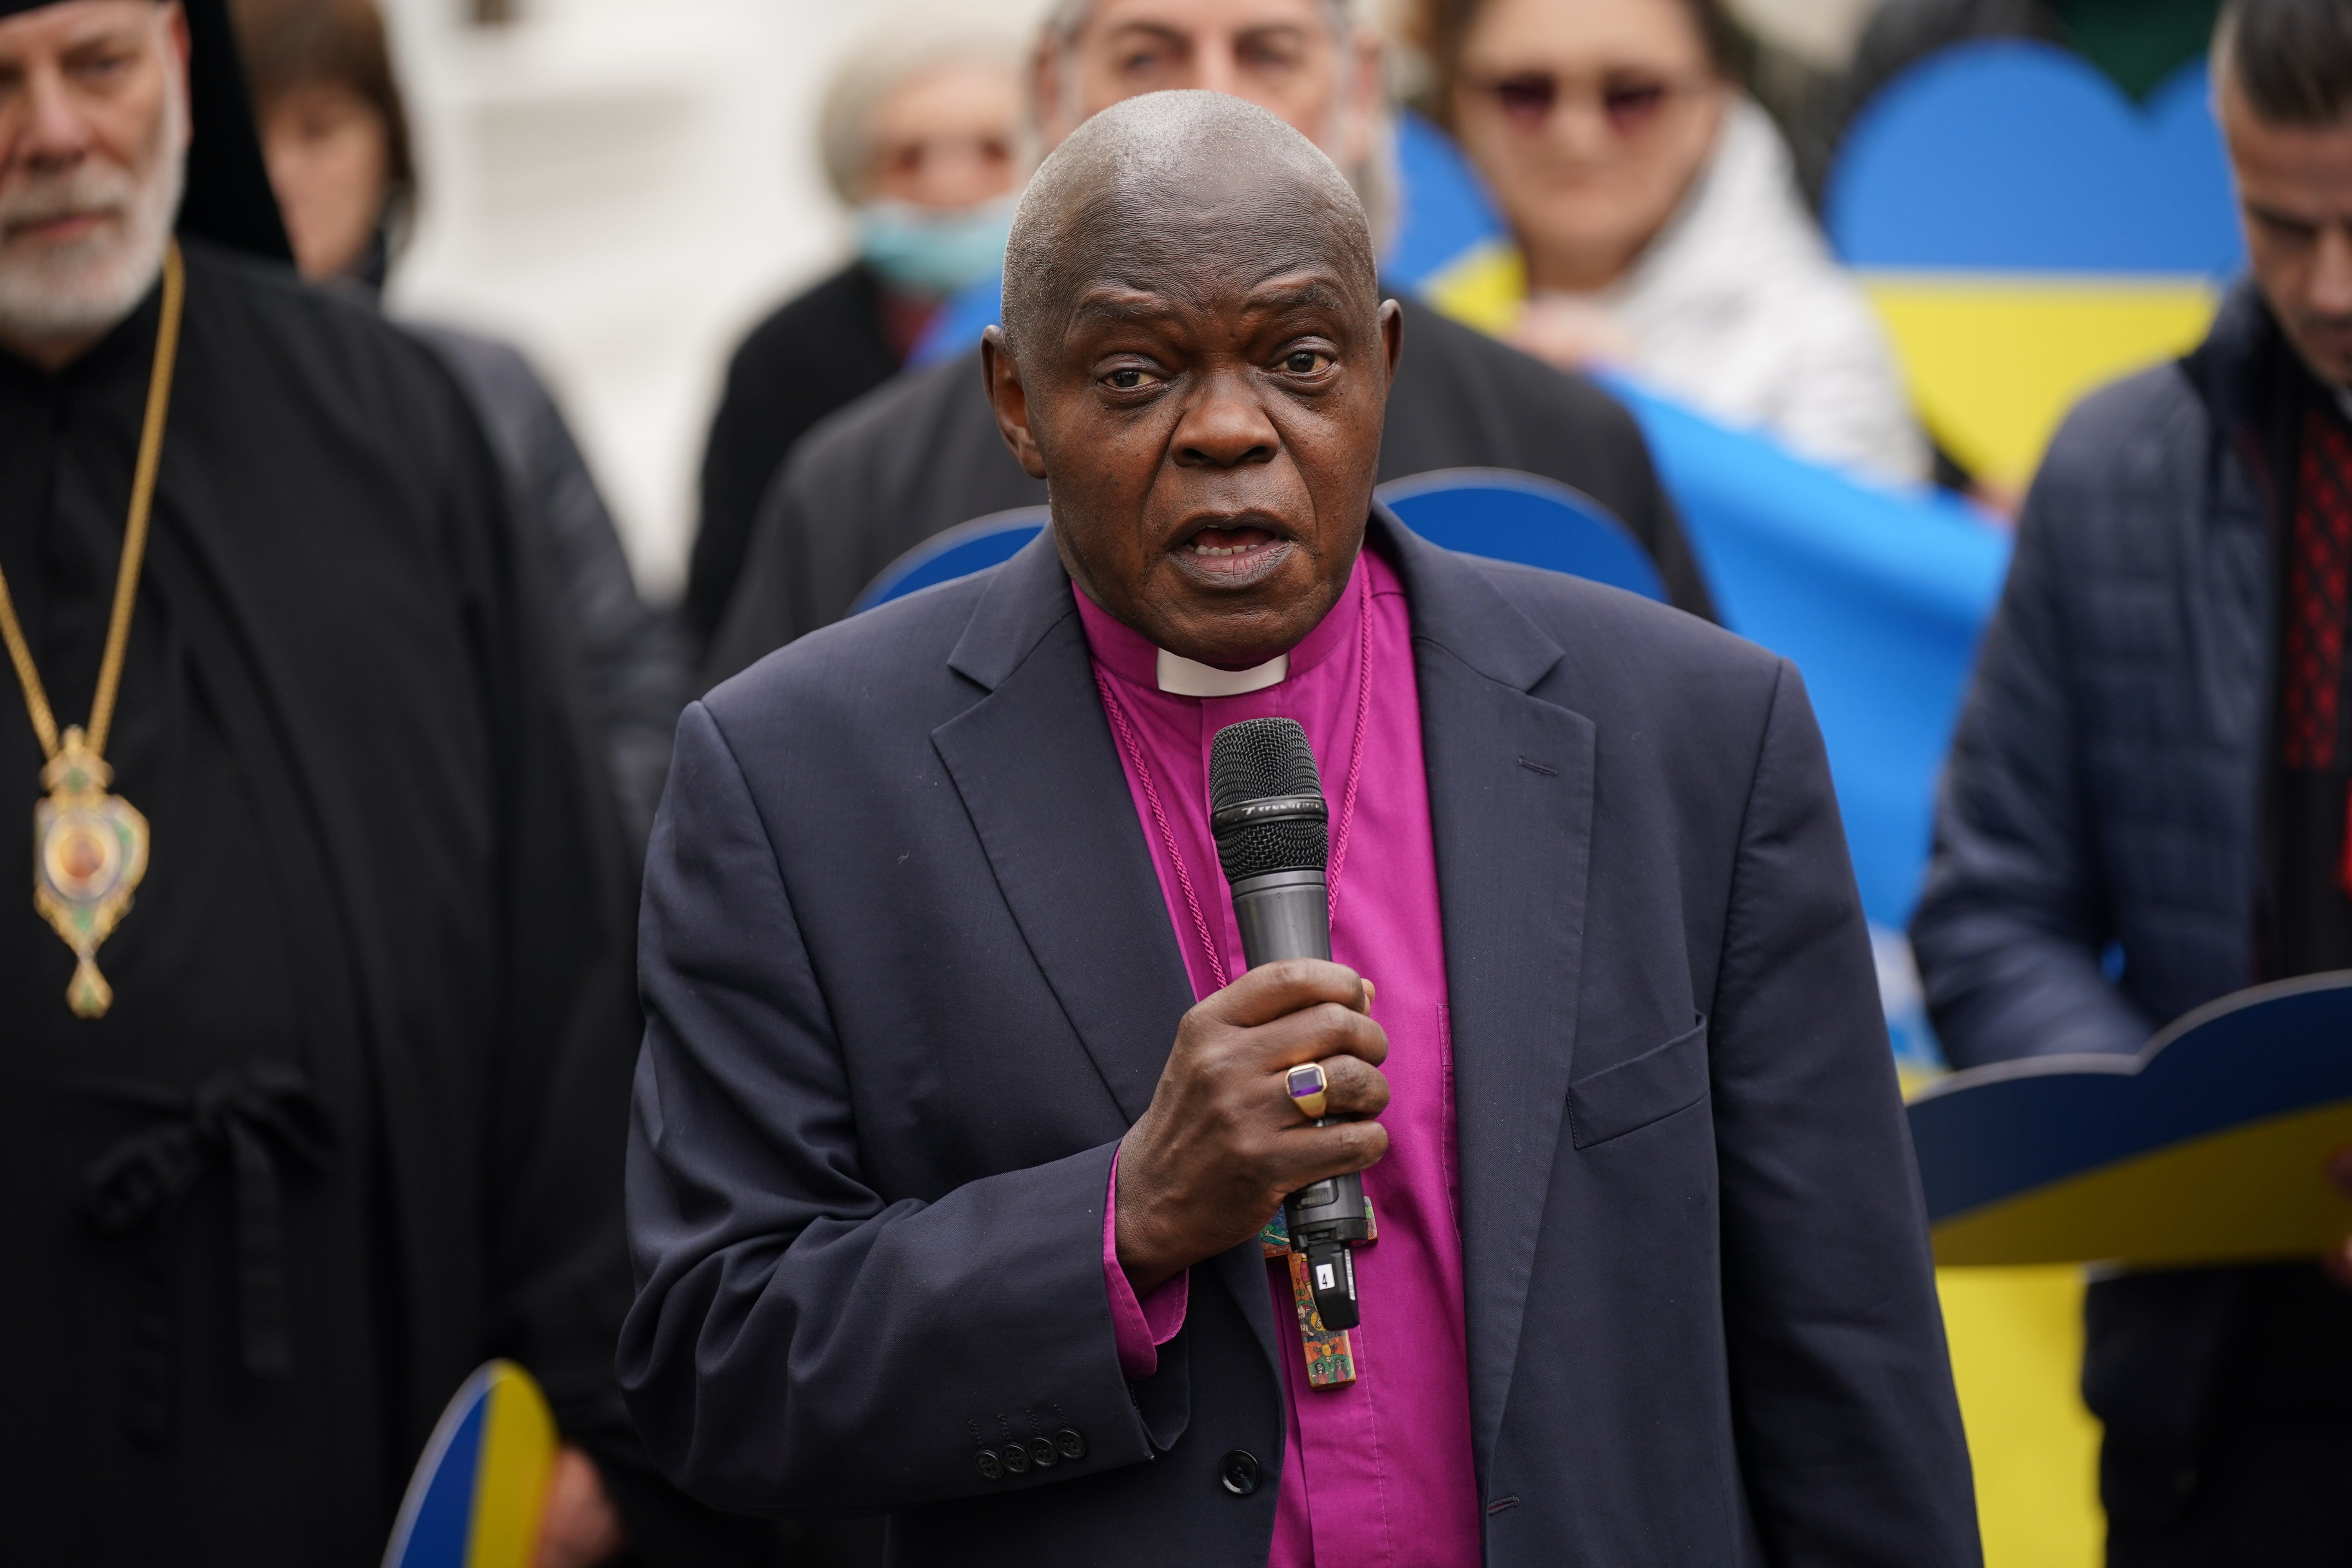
[1117,719,1388,1328]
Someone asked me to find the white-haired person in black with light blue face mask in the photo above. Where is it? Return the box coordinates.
[684,7,1030,658]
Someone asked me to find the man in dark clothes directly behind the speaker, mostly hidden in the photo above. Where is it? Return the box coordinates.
[703,0,1715,682]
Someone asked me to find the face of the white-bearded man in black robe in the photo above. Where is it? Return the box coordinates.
[0,0,188,359]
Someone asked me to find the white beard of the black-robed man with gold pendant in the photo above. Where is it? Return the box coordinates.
[0,82,188,341]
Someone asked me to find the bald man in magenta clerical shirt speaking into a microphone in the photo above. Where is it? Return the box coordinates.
[621,92,1978,1568]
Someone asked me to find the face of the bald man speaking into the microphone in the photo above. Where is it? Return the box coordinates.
[983,180,1399,668]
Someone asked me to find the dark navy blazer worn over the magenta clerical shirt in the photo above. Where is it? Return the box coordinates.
[621,512,1978,1568]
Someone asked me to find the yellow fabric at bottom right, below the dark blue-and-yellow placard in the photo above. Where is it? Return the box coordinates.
[1936,1267,2107,1568]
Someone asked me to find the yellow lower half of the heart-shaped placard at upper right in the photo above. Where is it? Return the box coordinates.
[1863,273,2220,489]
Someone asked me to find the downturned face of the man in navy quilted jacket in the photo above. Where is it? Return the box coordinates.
[2218,71,2352,386]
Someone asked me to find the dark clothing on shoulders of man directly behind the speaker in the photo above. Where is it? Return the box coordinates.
[703,299,1715,684]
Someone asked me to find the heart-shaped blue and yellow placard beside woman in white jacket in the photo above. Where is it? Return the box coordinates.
[1825,40,2244,489]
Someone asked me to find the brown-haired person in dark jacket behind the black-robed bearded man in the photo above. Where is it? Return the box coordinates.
[230,0,689,856]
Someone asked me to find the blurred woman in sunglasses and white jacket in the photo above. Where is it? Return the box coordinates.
[1416,0,1929,482]
